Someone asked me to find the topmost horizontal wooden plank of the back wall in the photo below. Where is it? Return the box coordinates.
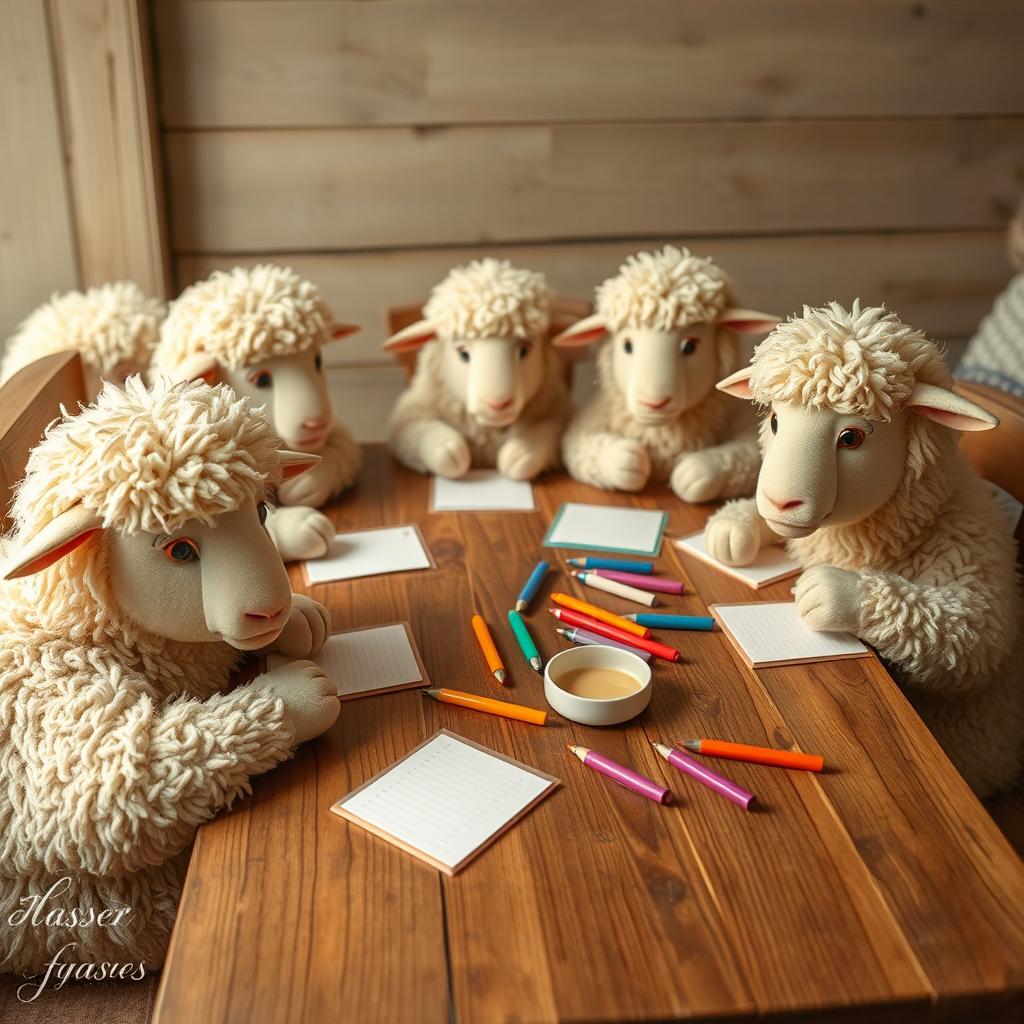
[155,0,1024,128]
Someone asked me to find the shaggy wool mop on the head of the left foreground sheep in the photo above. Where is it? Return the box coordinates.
[12,377,279,534]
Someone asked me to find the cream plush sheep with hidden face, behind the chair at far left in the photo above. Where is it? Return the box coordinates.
[0,281,166,399]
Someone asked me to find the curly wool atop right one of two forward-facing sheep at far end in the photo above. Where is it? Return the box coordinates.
[597,246,732,331]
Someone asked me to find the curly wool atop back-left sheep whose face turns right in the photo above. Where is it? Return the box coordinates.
[154,264,334,372]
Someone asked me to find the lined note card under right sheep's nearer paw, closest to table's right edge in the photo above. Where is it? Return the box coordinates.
[710,601,871,669]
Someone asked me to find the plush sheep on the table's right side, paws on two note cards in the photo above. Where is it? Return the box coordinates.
[707,302,1024,795]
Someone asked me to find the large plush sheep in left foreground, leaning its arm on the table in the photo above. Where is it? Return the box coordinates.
[0,378,339,974]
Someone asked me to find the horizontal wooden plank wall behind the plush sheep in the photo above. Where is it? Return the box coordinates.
[153,0,1024,426]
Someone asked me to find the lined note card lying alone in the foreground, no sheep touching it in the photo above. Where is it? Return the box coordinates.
[331,729,558,874]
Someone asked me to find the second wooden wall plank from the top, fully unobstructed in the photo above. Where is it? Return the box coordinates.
[166,118,1024,253]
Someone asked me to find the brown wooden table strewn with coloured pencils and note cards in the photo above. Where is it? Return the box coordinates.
[155,450,1024,1024]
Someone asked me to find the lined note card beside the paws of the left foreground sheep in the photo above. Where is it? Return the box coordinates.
[267,623,430,700]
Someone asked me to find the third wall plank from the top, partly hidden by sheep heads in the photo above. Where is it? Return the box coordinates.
[176,230,1011,366]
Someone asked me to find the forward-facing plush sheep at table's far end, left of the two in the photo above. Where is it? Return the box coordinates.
[384,259,570,480]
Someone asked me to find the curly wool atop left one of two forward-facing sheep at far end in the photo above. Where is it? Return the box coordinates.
[423,258,551,340]
